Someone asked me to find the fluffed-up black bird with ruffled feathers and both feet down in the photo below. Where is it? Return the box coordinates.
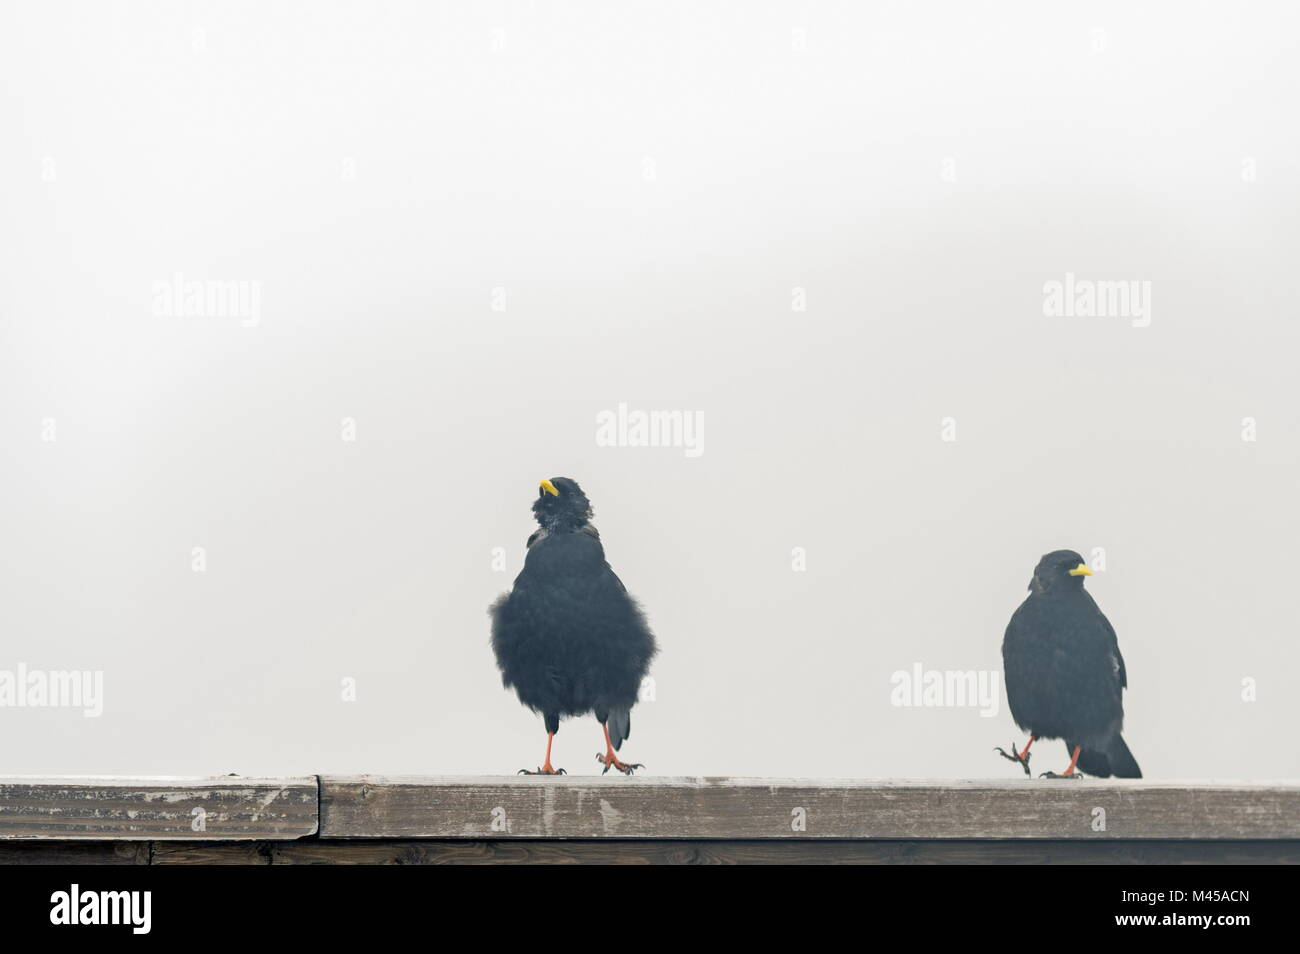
[489,477,655,775]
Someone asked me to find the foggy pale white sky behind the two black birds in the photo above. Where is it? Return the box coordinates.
[0,0,1300,779]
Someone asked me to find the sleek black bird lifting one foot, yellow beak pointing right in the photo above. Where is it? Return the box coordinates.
[997,550,1141,779]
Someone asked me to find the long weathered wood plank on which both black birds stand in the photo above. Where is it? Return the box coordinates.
[320,776,1300,841]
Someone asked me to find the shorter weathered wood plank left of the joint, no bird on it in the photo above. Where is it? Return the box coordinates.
[0,776,317,841]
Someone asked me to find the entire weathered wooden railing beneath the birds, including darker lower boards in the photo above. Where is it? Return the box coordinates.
[0,776,1300,864]
